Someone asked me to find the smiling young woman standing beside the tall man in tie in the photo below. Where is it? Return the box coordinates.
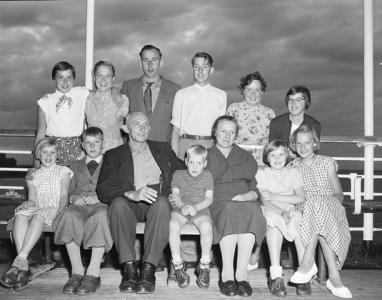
[85,60,129,152]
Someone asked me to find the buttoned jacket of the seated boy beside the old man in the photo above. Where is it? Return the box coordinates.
[69,157,102,202]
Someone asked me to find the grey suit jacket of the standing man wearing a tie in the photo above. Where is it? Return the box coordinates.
[121,77,180,142]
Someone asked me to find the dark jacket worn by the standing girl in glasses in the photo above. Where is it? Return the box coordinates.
[269,113,321,145]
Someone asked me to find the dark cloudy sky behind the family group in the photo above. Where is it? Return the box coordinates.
[0,0,382,166]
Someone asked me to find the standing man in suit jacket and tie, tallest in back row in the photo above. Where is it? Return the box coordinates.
[121,45,180,142]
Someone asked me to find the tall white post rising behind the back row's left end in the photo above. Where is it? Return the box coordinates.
[85,0,94,90]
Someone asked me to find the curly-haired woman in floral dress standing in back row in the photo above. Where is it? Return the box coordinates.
[227,71,275,166]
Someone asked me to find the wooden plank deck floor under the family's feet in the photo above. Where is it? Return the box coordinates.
[0,265,382,300]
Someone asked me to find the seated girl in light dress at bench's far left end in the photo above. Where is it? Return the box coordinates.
[0,137,73,290]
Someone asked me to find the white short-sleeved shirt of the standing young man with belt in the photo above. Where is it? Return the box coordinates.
[171,84,227,136]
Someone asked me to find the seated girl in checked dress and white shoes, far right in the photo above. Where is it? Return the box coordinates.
[290,125,352,298]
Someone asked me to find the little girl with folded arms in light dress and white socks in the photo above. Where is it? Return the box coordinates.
[256,140,305,297]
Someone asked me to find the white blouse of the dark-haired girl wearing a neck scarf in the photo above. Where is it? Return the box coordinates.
[37,86,89,137]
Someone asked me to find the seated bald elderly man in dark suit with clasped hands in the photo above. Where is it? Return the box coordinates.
[96,112,185,293]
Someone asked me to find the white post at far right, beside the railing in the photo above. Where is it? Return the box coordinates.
[363,0,374,242]
